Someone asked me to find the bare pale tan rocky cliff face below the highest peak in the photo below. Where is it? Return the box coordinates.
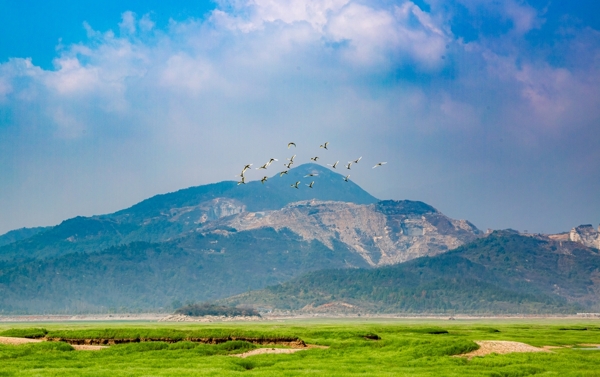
[200,200,481,266]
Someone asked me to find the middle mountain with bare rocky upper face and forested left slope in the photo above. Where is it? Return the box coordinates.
[0,197,479,312]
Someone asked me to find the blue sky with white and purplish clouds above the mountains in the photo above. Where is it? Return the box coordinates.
[0,0,600,234]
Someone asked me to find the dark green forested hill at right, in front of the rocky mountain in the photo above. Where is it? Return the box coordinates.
[222,231,600,313]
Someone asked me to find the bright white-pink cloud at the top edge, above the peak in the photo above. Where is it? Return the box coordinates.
[211,0,450,69]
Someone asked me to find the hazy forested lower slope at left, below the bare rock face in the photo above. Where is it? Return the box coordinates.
[0,228,368,313]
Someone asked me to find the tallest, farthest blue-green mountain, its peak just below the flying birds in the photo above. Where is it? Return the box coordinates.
[0,164,377,261]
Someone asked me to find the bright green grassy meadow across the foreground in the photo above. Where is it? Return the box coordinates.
[0,319,600,377]
